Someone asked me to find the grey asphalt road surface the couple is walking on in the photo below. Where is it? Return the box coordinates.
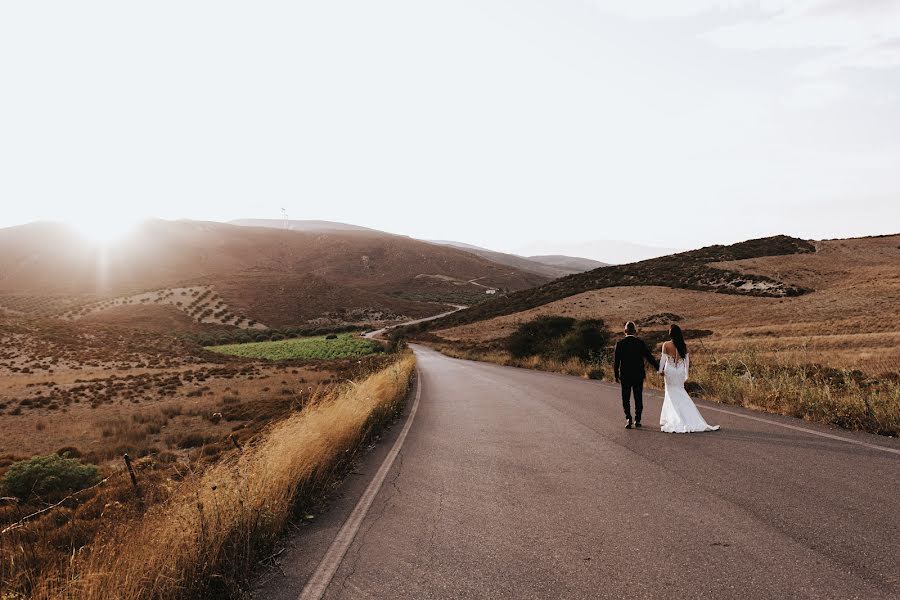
[255,348,900,600]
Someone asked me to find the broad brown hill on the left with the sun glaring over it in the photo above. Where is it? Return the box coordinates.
[0,220,547,325]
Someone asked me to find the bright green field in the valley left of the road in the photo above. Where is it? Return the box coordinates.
[206,333,379,360]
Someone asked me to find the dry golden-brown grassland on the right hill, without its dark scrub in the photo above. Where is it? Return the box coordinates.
[428,235,900,374]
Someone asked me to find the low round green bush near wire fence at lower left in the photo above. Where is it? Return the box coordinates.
[3,454,100,500]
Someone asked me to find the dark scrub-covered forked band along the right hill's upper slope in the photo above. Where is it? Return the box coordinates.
[418,236,815,330]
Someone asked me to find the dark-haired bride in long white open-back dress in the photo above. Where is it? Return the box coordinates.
[659,325,719,433]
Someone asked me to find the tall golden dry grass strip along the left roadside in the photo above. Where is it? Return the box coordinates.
[34,354,415,600]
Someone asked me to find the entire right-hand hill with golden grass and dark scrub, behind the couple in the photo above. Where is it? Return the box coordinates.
[420,235,900,370]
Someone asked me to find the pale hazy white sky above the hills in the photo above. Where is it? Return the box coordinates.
[0,0,900,249]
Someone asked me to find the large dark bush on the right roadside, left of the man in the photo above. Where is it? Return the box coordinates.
[506,316,609,362]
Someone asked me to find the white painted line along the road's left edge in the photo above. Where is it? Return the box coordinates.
[299,369,422,600]
